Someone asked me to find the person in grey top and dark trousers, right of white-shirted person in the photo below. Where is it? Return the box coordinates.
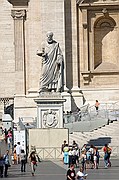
[20,149,26,172]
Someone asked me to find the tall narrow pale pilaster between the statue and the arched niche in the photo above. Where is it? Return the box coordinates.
[71,0,83,108]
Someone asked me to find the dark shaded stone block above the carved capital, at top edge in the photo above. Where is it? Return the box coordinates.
[7,0,30,7]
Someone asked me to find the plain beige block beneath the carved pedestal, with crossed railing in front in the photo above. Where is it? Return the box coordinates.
[29,128,69,159]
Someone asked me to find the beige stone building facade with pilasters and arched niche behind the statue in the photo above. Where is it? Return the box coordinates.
[0,0,119,121]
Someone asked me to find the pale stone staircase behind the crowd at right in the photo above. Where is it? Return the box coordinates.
[69,121,119,156]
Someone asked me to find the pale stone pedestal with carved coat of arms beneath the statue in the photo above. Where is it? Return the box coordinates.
[34,92,66,128]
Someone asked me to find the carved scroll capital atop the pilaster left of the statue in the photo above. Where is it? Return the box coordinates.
[11,10,26,19]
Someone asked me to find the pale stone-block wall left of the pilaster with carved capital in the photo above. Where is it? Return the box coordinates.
[0,0,15,97]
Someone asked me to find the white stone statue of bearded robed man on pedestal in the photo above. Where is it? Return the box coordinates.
[37,32,64,92]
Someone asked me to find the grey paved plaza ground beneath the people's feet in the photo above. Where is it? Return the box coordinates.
[3,159,119,180]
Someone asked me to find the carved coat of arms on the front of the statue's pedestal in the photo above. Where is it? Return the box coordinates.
[43,110,58,128]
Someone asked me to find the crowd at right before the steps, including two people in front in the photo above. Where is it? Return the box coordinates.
[61,141,112,180]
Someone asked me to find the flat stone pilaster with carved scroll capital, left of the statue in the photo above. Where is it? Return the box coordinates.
[11,9,26,94]
